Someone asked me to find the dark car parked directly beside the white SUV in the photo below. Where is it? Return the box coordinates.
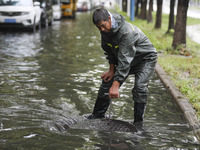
[36,0,53,27]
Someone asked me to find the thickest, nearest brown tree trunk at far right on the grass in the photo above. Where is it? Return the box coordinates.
[172,0,189,48]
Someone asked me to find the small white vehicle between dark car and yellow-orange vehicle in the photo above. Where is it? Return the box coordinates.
[52,0,62,20]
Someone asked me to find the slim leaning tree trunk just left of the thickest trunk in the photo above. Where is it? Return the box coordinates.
[167,0,176,33]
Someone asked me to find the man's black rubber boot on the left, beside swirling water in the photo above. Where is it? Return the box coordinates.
[88,96,110,119]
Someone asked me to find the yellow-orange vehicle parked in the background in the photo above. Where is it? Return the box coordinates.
[60,0,77,18]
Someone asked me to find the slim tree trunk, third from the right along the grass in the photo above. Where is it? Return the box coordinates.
[155,0,163,29]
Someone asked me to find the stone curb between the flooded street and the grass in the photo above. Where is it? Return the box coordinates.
[155,63,200,141]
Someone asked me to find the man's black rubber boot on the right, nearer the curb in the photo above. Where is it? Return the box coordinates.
[134,102,146,123]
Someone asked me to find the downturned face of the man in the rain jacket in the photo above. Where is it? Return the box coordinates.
[96,16,111,33]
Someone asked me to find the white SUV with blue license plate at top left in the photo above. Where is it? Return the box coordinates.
[0,0,42,31]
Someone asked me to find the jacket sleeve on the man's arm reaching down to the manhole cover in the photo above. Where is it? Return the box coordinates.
[114,31,139,84]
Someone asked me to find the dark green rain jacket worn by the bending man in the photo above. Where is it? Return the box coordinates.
[101,14,157,84]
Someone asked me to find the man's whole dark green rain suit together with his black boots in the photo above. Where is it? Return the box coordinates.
[91,14,157,118]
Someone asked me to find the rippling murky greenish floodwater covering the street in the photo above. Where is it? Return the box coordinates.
[0,13,200,150]
